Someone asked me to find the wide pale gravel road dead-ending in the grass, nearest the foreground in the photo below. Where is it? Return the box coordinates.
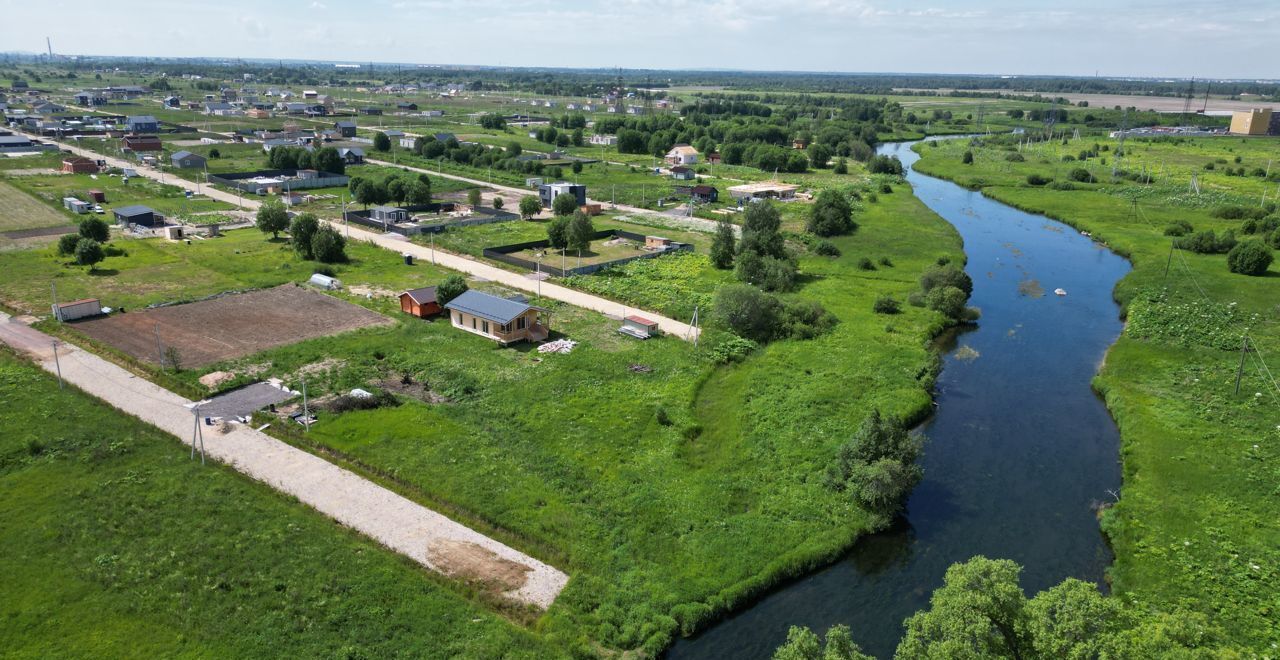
[0,315,568,609]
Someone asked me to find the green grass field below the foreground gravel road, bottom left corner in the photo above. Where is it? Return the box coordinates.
[0,350,562,659]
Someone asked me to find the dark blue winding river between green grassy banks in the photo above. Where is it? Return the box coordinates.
[667,138,1129,660]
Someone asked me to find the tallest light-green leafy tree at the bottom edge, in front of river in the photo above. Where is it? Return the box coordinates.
[896,556,1033,659]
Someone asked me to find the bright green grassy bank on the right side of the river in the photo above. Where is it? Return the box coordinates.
[916,138,1280,652]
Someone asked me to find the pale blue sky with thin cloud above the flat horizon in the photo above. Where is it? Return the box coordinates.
[10,0,1280,78]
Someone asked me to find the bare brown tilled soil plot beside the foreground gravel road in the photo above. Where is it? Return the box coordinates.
[76,284,394,368]
